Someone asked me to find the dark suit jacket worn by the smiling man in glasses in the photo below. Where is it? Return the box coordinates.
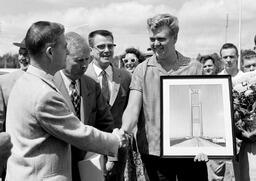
[85,62,131,128]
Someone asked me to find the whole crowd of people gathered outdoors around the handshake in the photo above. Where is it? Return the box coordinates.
[0,14,256,181]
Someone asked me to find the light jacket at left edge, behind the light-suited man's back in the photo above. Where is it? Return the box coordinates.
[0,69,24,132]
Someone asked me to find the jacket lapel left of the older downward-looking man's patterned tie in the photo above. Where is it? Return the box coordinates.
[54,71,76,114]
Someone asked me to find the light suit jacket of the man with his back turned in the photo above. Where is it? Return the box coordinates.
[6,66,119,181]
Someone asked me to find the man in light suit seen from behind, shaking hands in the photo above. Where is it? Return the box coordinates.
[6,21,126,181]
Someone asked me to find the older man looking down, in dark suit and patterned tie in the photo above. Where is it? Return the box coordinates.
[54,32,113,181]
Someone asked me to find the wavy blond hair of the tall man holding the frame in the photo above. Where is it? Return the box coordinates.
[147,14,179,36]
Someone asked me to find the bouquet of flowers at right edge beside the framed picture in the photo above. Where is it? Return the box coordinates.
[233,71,256,132]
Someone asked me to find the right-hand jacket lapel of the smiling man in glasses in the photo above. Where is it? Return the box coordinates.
[109,66,121,106]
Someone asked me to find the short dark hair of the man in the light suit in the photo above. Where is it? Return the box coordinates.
[25,21,65,56]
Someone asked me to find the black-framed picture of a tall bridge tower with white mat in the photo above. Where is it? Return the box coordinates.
[160,75,236,158]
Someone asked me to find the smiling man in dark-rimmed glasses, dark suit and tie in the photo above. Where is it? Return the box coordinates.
[85,30,131,180]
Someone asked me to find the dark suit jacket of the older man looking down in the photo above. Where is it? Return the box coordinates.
[54,71,114,132]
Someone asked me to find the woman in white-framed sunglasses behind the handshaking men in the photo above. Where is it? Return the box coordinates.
[121,48,145,74]
